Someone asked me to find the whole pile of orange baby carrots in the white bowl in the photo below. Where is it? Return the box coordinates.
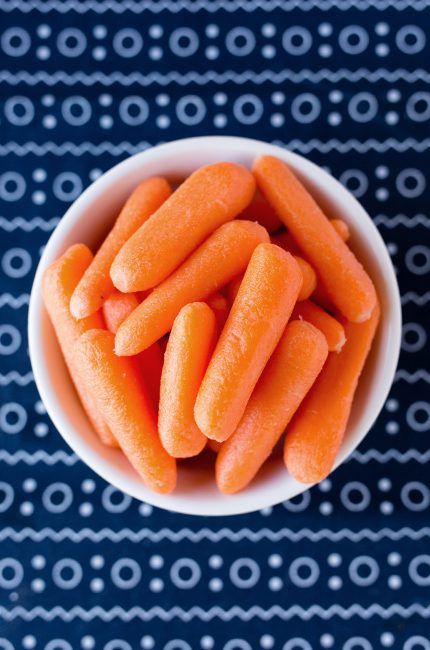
[43,156,380,494]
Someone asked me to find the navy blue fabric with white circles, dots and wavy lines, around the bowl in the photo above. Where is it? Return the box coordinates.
[0,0,430,650]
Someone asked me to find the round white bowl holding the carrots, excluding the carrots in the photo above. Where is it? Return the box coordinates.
[28,136,401,515]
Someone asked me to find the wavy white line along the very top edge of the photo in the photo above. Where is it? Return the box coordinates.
[0,0,429,14]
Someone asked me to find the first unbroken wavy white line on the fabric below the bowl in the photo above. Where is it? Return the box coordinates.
[0,527,430,544]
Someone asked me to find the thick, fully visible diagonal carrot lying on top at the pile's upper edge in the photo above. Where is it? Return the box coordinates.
[111,162,255,291]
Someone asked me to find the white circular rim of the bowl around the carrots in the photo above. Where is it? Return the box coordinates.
[28,136,402,516]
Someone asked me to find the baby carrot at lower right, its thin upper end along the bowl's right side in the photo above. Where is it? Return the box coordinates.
[284,304,380,483]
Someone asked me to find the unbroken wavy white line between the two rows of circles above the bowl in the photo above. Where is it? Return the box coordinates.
[0,68,430,86]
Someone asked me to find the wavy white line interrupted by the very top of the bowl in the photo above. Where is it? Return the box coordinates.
[0,138,430,158]
